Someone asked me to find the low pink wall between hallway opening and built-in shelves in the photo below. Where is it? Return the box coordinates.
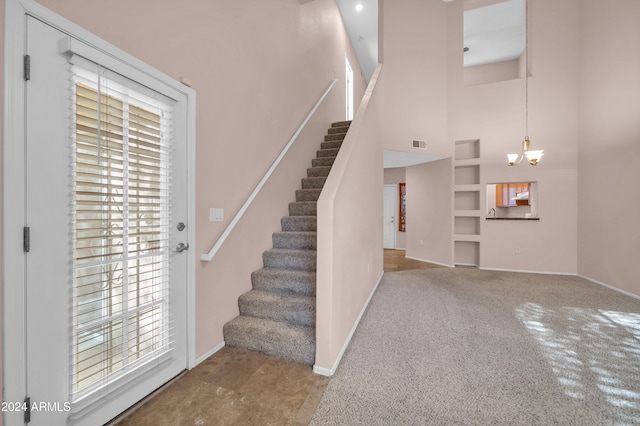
[407,158,453,265]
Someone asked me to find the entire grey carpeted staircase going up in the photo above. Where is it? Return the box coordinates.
[223,121,351,365]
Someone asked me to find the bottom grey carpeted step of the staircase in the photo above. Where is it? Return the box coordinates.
[223,315,316,365]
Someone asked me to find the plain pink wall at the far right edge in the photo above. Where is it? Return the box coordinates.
[578,0,640,295]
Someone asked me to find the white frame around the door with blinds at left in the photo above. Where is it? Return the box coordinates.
[2,0,196,424]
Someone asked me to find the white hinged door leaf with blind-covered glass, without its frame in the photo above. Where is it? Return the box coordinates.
[25,17,188,425]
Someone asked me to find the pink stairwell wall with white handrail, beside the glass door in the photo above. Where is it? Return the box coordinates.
[30,0,366,358]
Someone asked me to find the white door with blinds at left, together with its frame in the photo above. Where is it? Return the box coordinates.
[3,1,194,425]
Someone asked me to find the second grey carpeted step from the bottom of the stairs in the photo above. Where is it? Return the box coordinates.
[238,290,316,327]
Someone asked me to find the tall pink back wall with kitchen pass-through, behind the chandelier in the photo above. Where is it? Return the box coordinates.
[448,0,579,273]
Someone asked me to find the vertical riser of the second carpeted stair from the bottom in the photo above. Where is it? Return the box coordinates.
[238,295,316,327]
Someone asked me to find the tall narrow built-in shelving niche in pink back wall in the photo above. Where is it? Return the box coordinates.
[453,139,481,266]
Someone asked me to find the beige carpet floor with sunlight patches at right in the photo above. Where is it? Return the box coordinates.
[311,268,640,425]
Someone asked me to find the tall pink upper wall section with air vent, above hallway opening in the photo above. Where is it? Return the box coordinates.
[379,0,450,156]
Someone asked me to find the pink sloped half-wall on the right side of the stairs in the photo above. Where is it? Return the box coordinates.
[314,64,384,375]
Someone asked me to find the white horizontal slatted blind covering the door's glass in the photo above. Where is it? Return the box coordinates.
[70,66,174,401]
